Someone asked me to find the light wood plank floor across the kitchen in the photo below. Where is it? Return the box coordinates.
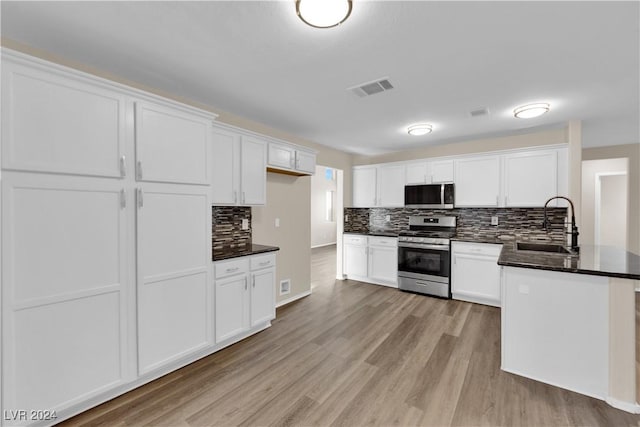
[65,247,640,426]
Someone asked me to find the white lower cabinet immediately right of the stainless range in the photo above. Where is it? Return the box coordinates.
[451,242,502,307]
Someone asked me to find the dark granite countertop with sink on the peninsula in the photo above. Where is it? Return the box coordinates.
[498,243,640,280]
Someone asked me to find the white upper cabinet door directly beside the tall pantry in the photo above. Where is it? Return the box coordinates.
[211,129,240,205]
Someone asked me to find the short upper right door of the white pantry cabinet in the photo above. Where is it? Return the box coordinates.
[136,102,211,185]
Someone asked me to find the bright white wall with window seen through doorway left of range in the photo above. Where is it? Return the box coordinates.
[311,165,338,248]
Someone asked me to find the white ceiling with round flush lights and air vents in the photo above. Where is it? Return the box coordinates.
[1,0,640,154]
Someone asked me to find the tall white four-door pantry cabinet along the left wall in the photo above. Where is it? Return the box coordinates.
[0,50,215,425]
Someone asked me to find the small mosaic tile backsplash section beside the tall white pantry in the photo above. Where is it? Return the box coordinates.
[211,206,251,253]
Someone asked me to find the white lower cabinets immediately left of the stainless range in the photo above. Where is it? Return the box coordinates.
[343,234,398,288]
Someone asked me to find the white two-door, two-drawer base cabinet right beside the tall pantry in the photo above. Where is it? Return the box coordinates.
[214,254,276,344]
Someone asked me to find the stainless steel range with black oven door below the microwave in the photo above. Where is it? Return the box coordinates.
[398,216,456,298]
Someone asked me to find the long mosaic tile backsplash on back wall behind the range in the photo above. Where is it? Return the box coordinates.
[344,208,567,242]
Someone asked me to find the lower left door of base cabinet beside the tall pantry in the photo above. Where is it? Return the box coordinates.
[216,274,249,343]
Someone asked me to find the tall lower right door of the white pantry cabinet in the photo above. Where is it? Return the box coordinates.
[137,184,213,373]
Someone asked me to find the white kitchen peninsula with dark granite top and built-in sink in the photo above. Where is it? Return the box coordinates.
[498,243,640,413]
